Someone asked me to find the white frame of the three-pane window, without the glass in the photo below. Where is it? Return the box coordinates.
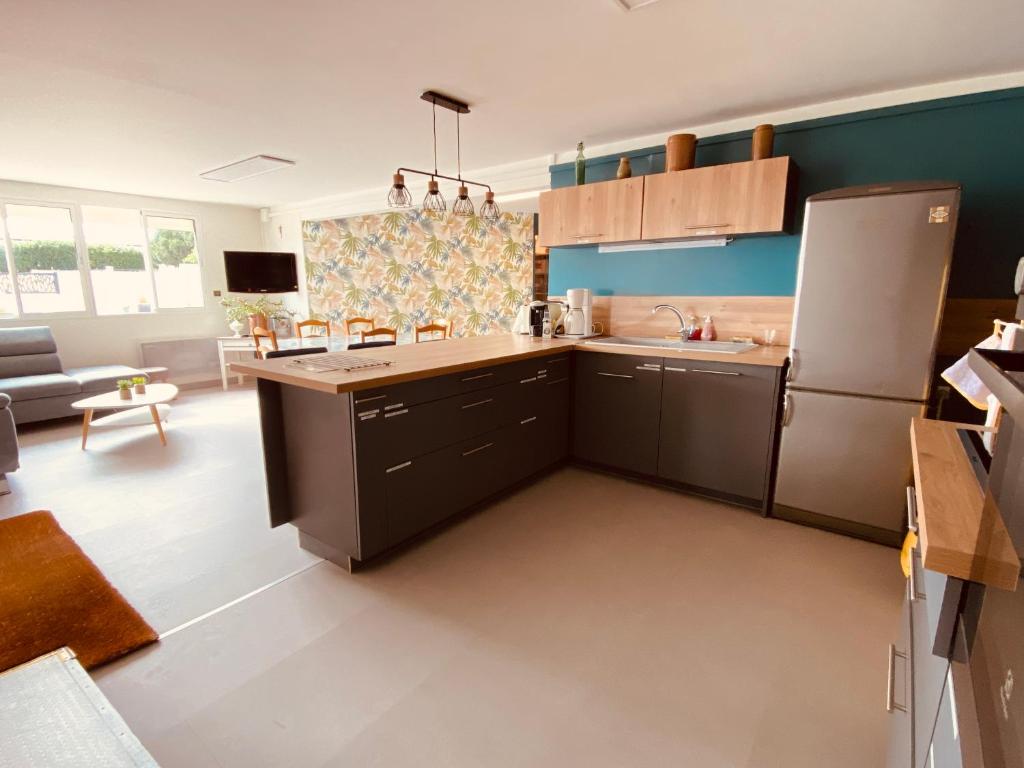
[0,197,210,323]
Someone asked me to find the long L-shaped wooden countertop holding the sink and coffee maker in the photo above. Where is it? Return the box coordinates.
[230,334,788,394]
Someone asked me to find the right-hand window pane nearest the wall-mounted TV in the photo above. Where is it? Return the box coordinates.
[145,216,203,309]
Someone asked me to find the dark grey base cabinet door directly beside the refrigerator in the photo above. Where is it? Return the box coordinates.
[657,358,780,507]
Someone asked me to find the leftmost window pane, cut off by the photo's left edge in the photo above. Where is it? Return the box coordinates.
[5,204,85,313]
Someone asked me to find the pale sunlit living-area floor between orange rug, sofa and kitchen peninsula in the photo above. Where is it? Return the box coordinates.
[0,388,317,632]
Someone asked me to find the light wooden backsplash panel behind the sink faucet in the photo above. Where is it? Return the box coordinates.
[552,296,794,346]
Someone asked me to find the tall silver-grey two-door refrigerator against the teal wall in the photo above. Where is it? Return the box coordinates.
[772,181,959,544]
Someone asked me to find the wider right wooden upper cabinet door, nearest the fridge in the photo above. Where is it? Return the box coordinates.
[642,158,793,240]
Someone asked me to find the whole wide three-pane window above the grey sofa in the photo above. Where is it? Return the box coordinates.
[0,202,205,317]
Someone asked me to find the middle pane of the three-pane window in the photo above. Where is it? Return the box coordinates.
[82,206,153,314]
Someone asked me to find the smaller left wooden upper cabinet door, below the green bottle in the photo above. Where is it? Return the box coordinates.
[538,176,645,247]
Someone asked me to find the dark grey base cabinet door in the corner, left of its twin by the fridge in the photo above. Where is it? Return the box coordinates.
[572,352,662,475]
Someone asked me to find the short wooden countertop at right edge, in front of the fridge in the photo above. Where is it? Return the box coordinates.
[910,418,1021,591]
